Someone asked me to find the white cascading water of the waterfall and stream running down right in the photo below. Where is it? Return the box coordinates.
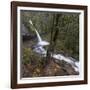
[29,20,80,72]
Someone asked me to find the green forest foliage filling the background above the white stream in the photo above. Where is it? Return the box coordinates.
[21,11,79,61]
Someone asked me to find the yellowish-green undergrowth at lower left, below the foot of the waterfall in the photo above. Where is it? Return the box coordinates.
[22,47,45,77]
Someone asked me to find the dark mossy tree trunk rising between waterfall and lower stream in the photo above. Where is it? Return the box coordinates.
[46,14,59,64]
